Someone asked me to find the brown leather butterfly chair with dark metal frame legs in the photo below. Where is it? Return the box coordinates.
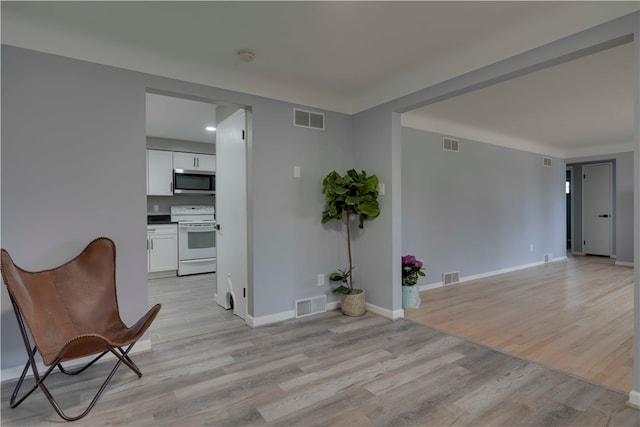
[1,237,160,421]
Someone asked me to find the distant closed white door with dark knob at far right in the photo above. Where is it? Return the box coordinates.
[582,163,612,256]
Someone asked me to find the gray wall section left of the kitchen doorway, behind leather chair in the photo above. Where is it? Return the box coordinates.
[1,46,148,368]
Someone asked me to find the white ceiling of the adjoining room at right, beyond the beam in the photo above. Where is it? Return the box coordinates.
[402,44,634,158]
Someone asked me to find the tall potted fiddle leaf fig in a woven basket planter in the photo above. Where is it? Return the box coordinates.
[321,169,380,316]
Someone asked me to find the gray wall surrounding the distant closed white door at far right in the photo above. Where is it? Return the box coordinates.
[567,152,633,263]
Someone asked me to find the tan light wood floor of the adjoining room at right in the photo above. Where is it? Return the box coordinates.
[405,257,633,393]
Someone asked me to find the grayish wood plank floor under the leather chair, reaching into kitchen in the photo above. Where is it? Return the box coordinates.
[1,270,640,427]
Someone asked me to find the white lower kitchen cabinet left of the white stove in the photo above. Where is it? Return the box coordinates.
[147,224,178,273]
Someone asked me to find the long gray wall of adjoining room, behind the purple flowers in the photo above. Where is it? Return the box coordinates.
[402,128,566,284]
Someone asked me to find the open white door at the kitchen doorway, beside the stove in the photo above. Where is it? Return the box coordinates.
[216,109,247,319]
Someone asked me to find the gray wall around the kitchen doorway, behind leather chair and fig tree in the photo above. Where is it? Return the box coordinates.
[1,45,353,368]
